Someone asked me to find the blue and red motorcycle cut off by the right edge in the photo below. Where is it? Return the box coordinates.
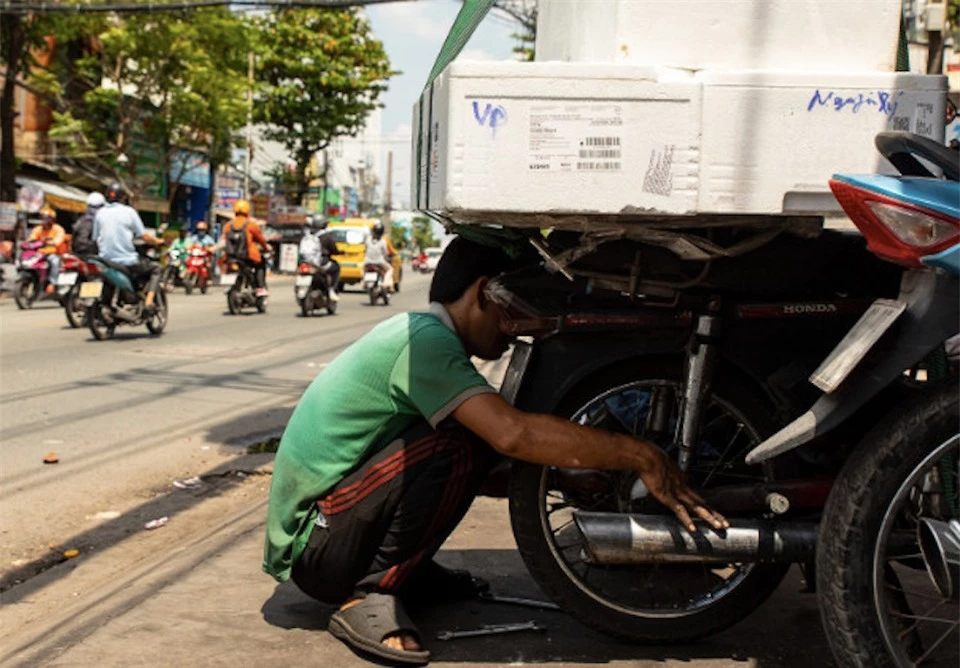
[748,133,960,667]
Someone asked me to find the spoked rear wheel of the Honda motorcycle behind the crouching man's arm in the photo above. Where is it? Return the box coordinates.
[510,360,789,643]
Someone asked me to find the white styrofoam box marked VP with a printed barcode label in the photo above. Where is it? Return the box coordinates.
[411,61,701,214]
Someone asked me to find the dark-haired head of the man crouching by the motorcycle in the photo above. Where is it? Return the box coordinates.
[430,237,519,360]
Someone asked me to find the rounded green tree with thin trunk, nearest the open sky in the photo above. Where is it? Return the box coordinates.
[254,9,396,204]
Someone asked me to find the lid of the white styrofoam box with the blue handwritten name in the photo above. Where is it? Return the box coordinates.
[694,70,947,90]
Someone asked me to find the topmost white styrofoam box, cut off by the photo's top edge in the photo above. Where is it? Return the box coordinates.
[536,0,901,72]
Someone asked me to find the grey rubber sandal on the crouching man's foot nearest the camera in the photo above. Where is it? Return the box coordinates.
[327,594,430,666]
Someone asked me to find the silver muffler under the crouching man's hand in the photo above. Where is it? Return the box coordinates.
[574,510,819,565]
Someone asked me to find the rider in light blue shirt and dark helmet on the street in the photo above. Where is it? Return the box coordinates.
[93,183,160,313]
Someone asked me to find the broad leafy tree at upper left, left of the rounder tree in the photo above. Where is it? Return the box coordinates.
[36,8,248,204]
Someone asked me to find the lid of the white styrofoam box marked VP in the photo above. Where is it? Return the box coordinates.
[441,60,694,82]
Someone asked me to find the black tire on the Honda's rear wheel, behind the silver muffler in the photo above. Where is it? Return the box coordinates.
[510,359,789,643]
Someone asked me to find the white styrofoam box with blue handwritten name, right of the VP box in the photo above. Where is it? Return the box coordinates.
[696,71,947,213]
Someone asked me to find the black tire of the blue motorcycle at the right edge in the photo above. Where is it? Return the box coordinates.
[816,385,960,668]
